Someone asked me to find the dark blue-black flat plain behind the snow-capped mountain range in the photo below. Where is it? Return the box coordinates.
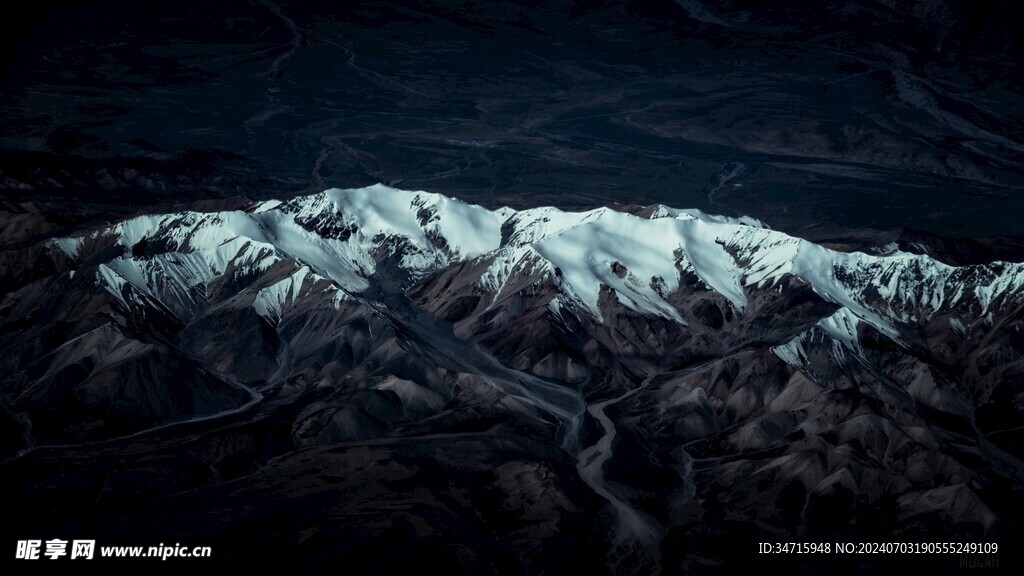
[6,0,1024,239]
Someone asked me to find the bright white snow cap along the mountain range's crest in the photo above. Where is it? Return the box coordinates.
[51,184,1024,332]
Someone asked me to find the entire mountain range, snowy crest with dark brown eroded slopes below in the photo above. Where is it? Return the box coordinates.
[0,187,1024,573]
